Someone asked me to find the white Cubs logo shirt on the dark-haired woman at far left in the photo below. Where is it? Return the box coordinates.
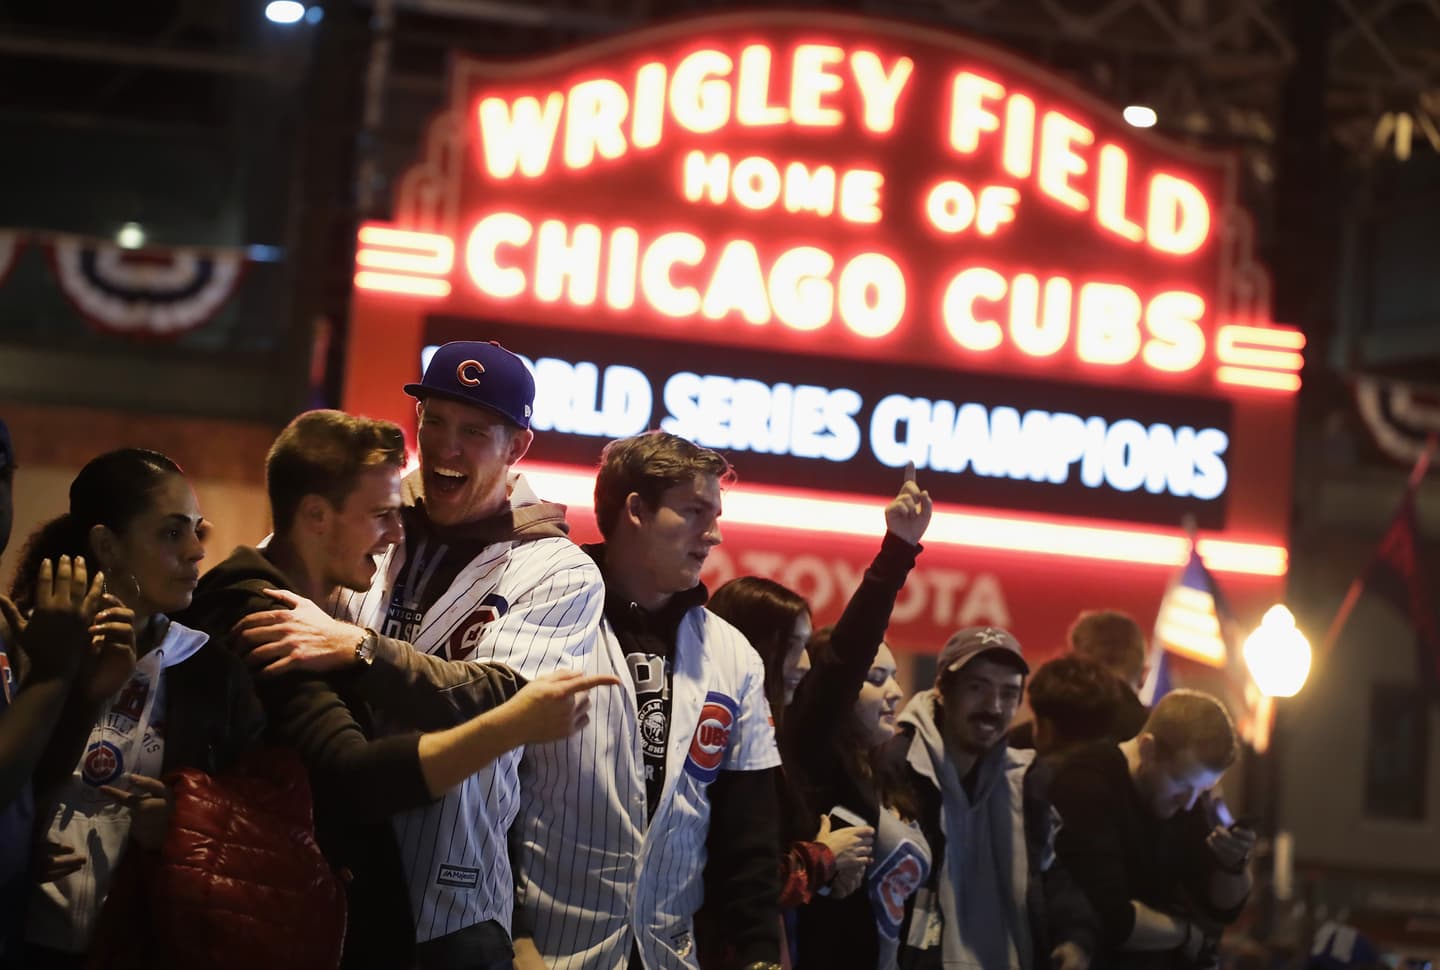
[26,622,210,953]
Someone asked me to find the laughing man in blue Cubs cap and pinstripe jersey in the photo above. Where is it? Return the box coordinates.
[240,341,605,970]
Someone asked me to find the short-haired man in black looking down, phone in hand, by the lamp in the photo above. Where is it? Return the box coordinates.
[1051,691,1256,969]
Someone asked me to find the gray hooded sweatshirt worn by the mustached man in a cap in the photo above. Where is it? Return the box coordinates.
[900,691,1035,970]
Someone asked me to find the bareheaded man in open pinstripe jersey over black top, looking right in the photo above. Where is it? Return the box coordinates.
[511,432,780,970]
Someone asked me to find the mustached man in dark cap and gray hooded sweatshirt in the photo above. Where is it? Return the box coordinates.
[888,626,1096,970]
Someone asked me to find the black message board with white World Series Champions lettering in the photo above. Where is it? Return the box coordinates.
[422,319,1231,527]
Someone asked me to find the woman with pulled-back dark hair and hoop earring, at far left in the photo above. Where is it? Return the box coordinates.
[13,449,262,967]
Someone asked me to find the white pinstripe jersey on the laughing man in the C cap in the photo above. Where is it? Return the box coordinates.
[341,476,605,943]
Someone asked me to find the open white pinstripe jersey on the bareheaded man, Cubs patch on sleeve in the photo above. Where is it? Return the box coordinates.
[513,606,780,970]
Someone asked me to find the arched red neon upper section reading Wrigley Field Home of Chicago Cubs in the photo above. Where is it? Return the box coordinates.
[356,13,1303,394]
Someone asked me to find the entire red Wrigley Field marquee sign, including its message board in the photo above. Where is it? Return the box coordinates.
[344,12,1305,653]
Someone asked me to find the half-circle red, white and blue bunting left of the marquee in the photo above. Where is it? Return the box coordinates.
[49,236,245,337]
